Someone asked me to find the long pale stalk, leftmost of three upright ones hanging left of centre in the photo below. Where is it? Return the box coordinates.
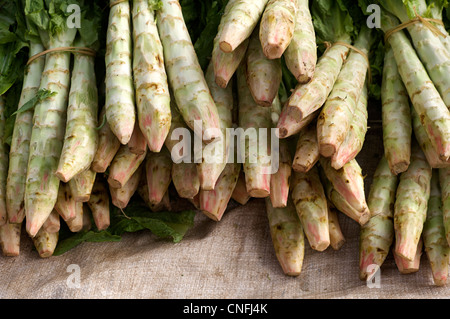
[105,0,136,144]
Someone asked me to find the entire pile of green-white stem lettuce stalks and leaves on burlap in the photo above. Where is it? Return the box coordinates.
[0,0,450,285]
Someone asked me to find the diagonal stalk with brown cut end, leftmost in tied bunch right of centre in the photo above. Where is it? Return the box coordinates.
[277,38,350,138]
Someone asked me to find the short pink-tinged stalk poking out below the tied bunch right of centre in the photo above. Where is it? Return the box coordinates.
[319,157,370,225]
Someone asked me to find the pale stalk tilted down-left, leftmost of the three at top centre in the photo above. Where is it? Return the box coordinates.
[218,0,268,53]
